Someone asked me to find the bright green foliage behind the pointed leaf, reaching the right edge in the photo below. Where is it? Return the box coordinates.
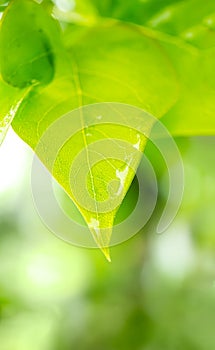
[60,0,215,135]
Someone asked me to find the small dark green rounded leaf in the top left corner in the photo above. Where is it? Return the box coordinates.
[0,0,55,88]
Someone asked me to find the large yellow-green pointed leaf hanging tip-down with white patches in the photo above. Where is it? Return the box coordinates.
[0,18,177,259]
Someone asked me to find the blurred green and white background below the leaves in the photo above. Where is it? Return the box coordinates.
[0,131,215,350]
